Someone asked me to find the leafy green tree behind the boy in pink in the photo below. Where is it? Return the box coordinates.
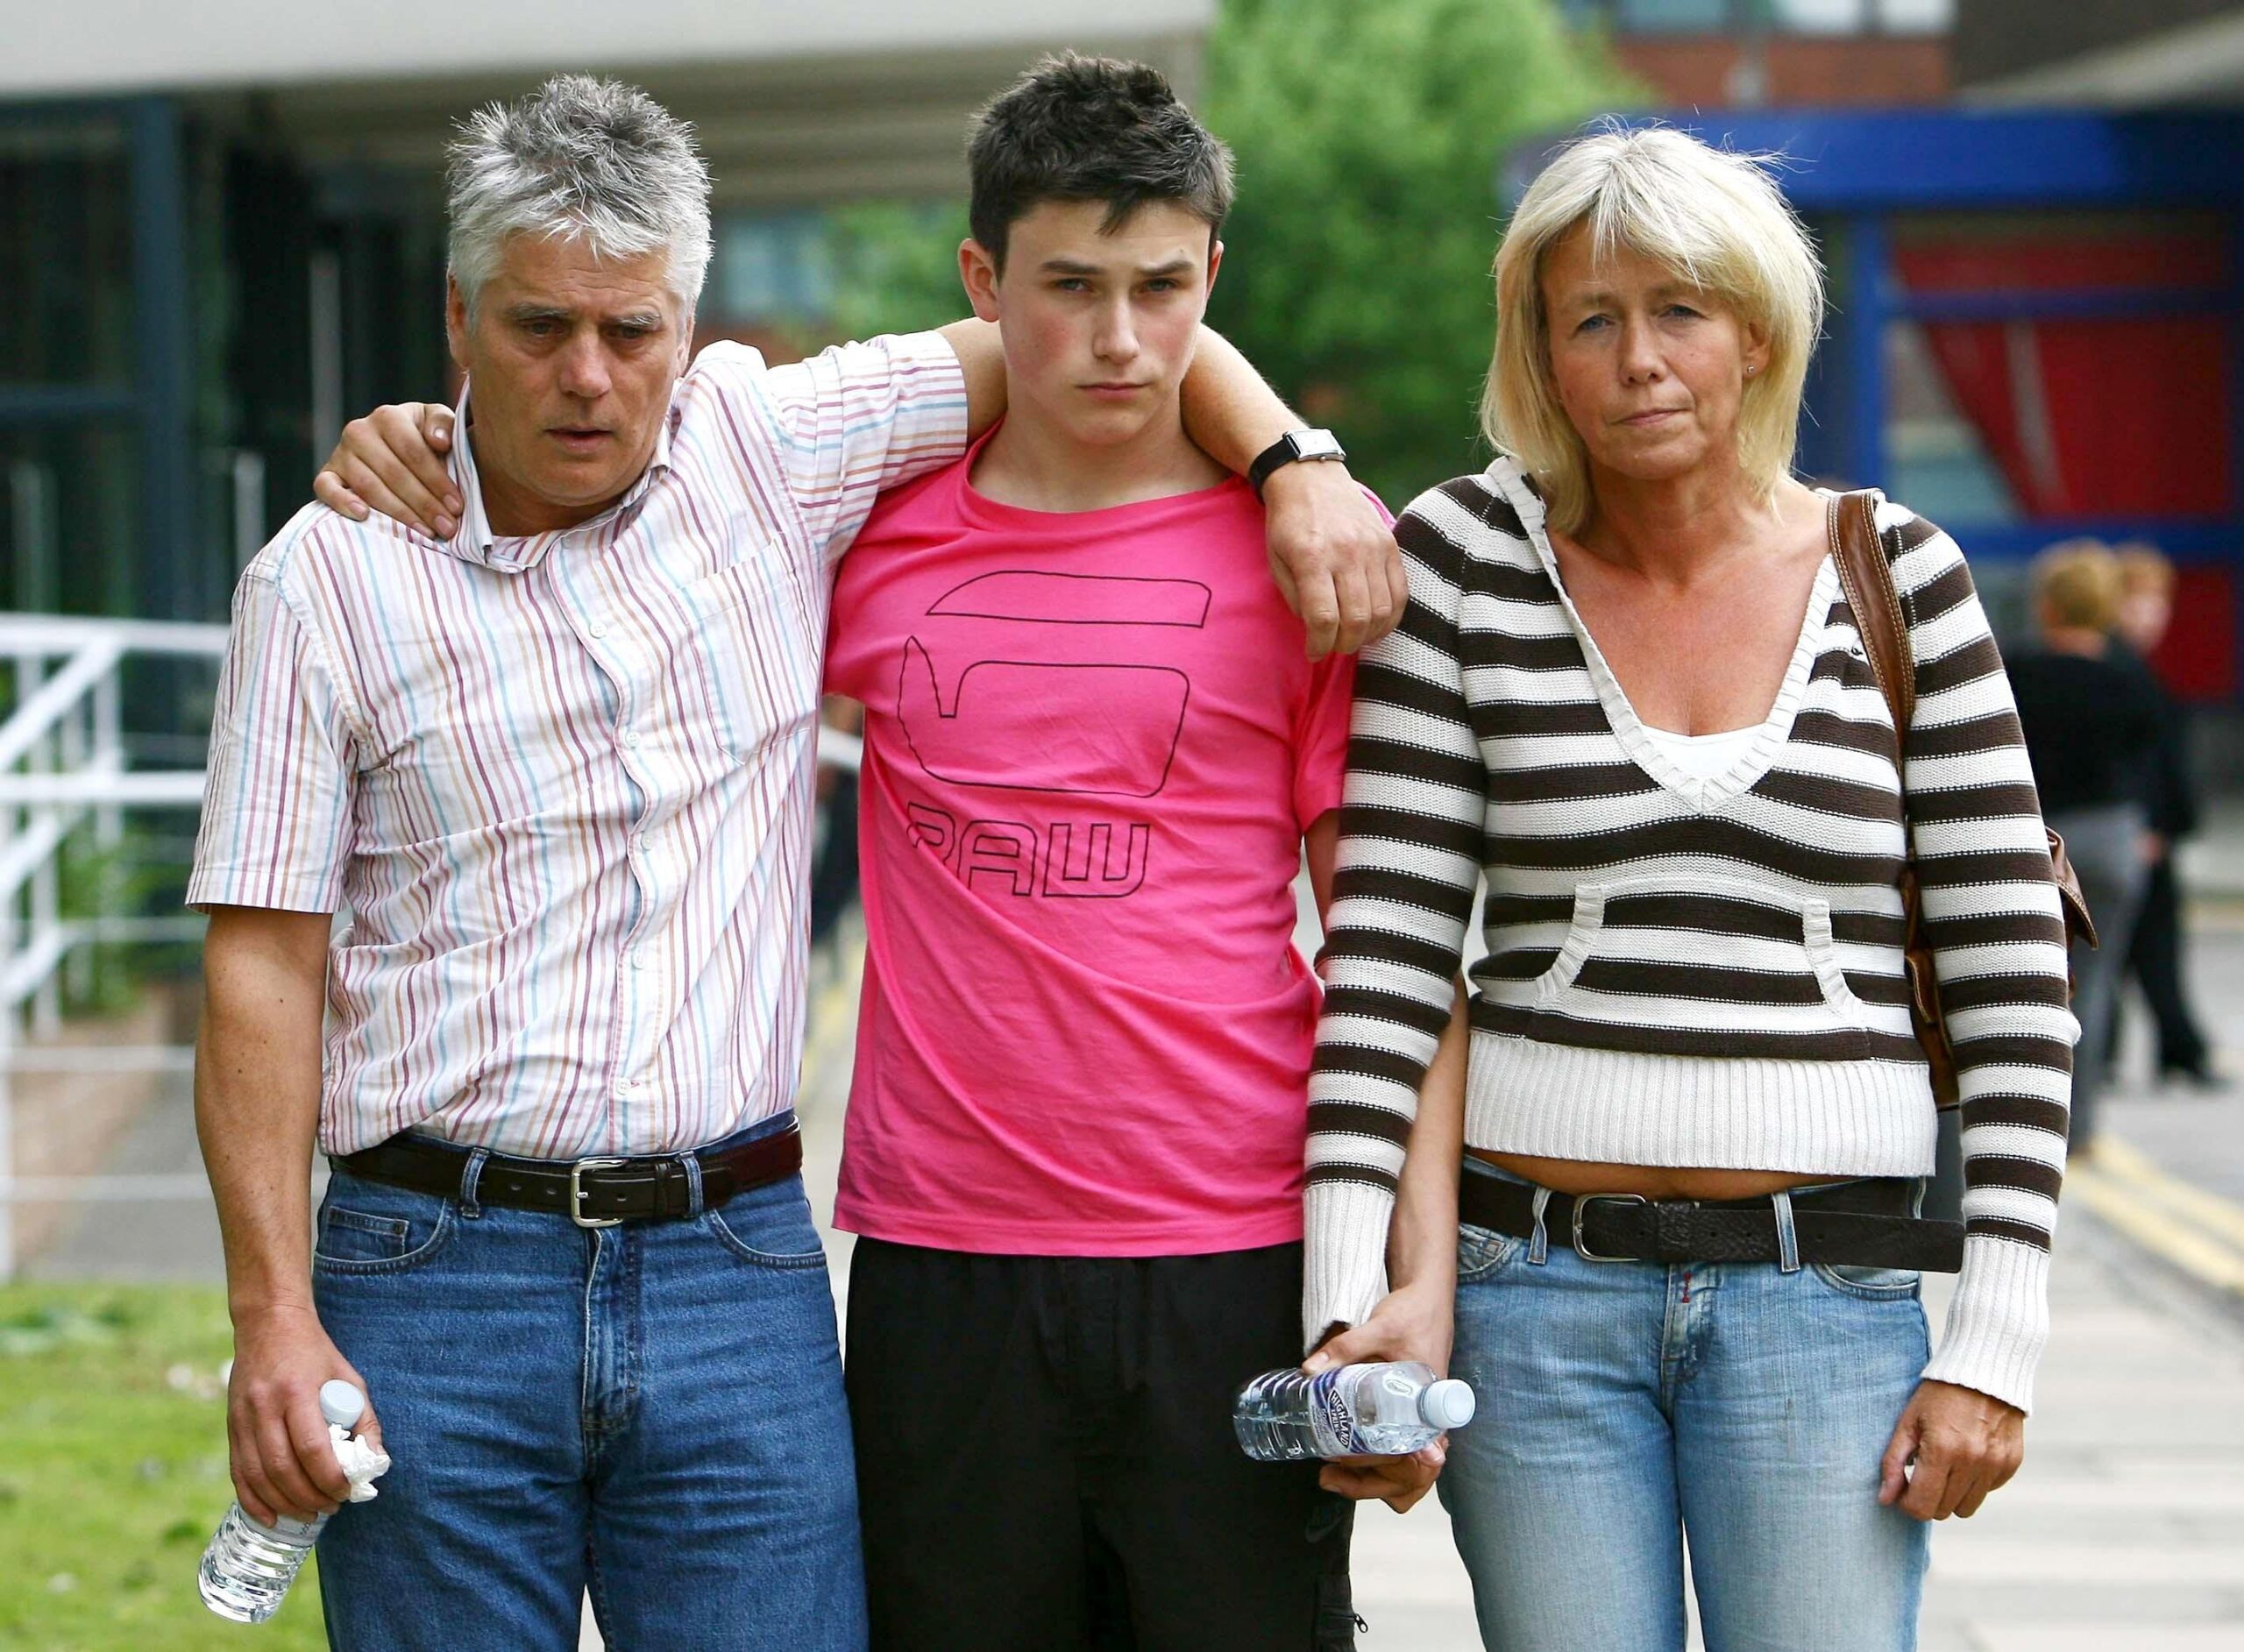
[834,0,1636,505]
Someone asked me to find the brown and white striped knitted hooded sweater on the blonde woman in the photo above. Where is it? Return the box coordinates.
[1303,457,2076,1407]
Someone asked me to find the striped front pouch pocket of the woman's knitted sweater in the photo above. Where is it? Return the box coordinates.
[1506,876,1869,1061]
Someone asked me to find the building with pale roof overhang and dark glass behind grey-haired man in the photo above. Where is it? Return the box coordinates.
[0,0,1214,620]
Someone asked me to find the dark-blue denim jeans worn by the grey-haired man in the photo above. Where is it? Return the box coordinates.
[312,1117,866,1652]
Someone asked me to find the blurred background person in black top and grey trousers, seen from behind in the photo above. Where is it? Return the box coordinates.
[2011,539,2165,1153]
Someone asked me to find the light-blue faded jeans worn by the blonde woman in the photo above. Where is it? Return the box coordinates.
[1438,1159,1928,1652]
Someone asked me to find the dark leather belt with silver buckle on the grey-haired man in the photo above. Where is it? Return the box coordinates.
[334,1124,803,1228]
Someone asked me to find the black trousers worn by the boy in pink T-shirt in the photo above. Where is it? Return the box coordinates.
[846,1239,1355,1652]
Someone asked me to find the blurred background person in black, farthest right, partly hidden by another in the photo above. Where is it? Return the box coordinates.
[2107,543,2221,1091]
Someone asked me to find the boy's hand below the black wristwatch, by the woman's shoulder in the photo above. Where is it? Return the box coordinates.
[1263,460,1410,660]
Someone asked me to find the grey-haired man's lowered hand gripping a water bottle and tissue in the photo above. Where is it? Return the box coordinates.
[227,1307,381,1527]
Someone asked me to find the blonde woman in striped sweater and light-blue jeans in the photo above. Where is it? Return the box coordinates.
[1303,131,2073,1652]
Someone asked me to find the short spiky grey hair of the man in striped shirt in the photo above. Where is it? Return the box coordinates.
[444,74,709,316]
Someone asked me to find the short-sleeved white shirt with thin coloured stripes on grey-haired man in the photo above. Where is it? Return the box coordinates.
[188,335,967,1159]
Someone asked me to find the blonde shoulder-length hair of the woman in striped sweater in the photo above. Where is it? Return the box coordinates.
[1481,125,1824,532]
